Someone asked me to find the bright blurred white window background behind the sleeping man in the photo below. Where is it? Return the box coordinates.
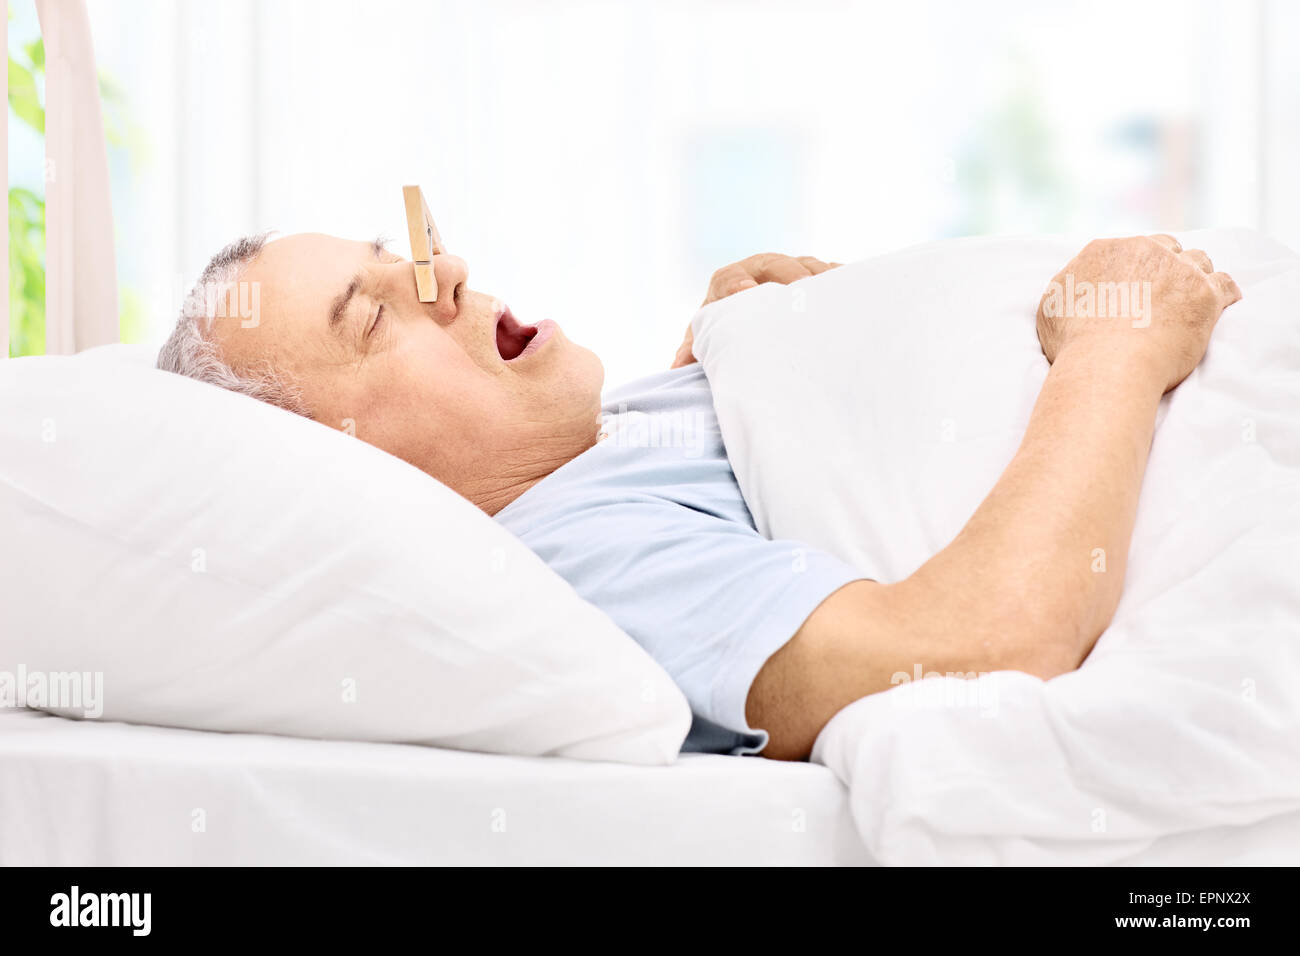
[9,0,1300,384]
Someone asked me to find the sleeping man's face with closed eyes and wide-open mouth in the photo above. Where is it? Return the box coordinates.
[215,234,603,512]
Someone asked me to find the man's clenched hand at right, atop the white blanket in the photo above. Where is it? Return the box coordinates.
[1037,234,1242,392]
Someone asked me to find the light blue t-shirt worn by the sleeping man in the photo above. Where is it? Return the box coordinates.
[497,364,862,753]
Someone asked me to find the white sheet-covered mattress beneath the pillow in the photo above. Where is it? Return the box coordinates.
[0,710,870,866]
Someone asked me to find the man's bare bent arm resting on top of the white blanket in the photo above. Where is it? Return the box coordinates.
[746,237,1240,760]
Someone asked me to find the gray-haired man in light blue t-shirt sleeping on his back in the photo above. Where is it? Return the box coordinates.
[159,234,1240,760]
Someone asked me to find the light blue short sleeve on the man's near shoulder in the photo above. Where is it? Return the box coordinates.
[499,496,863,753]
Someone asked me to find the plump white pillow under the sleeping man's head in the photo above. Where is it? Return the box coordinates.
[0,346,690,763]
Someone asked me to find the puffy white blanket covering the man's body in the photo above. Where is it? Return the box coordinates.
[694,230,1300,864]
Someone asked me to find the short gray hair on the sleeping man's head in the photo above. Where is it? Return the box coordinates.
[157,233,312,418]
